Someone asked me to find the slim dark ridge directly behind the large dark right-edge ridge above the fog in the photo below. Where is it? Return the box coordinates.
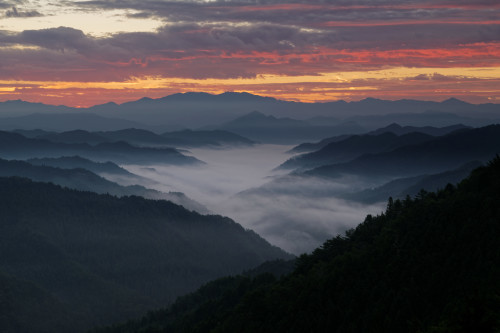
[280,132,434,169]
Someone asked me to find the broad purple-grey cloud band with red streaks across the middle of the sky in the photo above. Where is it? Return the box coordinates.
[0,23,500,81]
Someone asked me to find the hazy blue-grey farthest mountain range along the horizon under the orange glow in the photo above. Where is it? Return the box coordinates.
[0,92,500,137]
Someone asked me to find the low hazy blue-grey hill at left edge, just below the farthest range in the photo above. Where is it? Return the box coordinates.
[0,113,147,132]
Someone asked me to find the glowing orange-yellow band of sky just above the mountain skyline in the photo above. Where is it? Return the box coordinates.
[0,63,500,107]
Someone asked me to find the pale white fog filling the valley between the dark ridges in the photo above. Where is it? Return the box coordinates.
[123,145,385,254]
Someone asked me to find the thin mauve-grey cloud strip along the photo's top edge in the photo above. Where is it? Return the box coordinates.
[74,0,498,25]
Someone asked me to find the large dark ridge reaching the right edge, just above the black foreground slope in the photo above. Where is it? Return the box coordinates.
[304,125,500,179]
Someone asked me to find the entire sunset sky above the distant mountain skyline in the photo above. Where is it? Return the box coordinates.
[0,0,500,107]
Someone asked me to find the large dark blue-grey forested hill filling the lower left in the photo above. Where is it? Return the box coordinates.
[0,178,290,333]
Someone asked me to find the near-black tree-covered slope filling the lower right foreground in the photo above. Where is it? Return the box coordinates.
[99,157,500,333]
